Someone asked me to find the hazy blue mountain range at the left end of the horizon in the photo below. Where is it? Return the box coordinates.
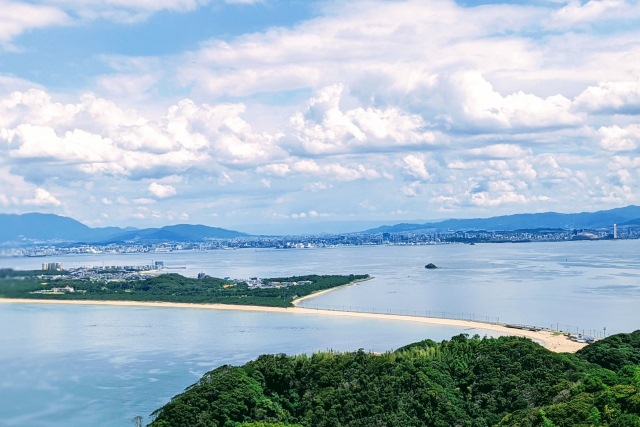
[0,213,247,243]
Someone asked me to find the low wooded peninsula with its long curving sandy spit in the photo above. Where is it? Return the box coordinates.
[0,270,585,352]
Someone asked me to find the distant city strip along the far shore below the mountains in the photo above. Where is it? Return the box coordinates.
[0,224,640,257]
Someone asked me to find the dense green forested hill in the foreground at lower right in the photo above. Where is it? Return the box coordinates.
[150,331,640,427]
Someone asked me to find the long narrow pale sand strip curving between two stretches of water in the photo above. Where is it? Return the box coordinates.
[0,293,585,353]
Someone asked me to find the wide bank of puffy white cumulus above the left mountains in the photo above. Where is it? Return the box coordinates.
[0,90,284,183]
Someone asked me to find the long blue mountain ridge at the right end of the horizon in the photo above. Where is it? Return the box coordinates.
[364,206,640,234]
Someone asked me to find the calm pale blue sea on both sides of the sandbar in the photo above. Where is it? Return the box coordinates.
[0,240,640,427]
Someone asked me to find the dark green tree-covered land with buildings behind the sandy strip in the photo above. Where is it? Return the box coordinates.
[0,270,369,307]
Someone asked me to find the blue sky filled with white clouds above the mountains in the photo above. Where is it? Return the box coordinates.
[0,0,640,233]
